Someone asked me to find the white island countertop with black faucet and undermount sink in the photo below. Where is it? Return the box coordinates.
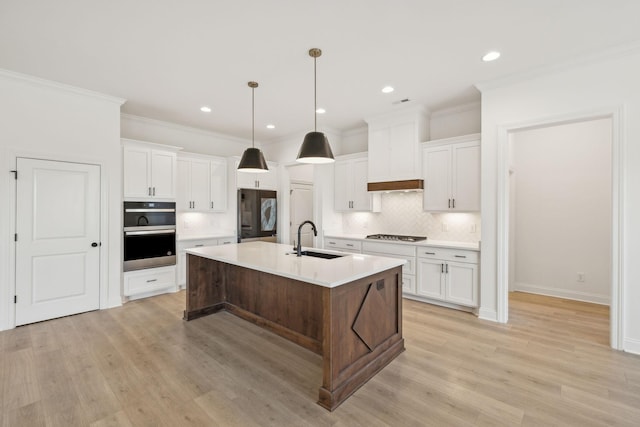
[186,242,406,288]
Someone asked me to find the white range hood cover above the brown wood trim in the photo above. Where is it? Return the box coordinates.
[366,107,428,182]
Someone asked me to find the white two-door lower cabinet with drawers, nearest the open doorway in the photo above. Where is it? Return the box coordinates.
[416,247,478,307]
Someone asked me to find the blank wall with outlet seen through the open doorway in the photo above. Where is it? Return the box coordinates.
[510,119,612,304]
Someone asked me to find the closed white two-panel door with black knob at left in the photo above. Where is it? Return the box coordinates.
[16,158,100,326]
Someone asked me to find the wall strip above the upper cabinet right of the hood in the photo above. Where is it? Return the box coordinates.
[429,102,480,140]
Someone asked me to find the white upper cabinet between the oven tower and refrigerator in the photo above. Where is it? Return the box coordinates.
[176,154,227,212]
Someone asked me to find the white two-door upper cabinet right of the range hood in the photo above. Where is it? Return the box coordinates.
[422,134,480,212]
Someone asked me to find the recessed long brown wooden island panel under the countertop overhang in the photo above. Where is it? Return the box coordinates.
[225,264,324,354]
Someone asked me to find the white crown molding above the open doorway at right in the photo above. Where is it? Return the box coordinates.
[474,41,640,92]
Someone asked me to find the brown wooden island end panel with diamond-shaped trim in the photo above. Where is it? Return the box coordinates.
[318,267,404,410]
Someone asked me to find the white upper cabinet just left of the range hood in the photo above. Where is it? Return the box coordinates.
[334,153,381,212]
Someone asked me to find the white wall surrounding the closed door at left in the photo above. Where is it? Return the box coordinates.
[0,71,123,330]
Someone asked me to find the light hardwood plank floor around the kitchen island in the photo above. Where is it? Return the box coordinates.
[0,292,640,427]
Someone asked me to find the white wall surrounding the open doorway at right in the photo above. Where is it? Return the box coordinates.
[480,47,640,353]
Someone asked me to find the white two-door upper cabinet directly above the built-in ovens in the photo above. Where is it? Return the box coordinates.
[122,139,180,200]
